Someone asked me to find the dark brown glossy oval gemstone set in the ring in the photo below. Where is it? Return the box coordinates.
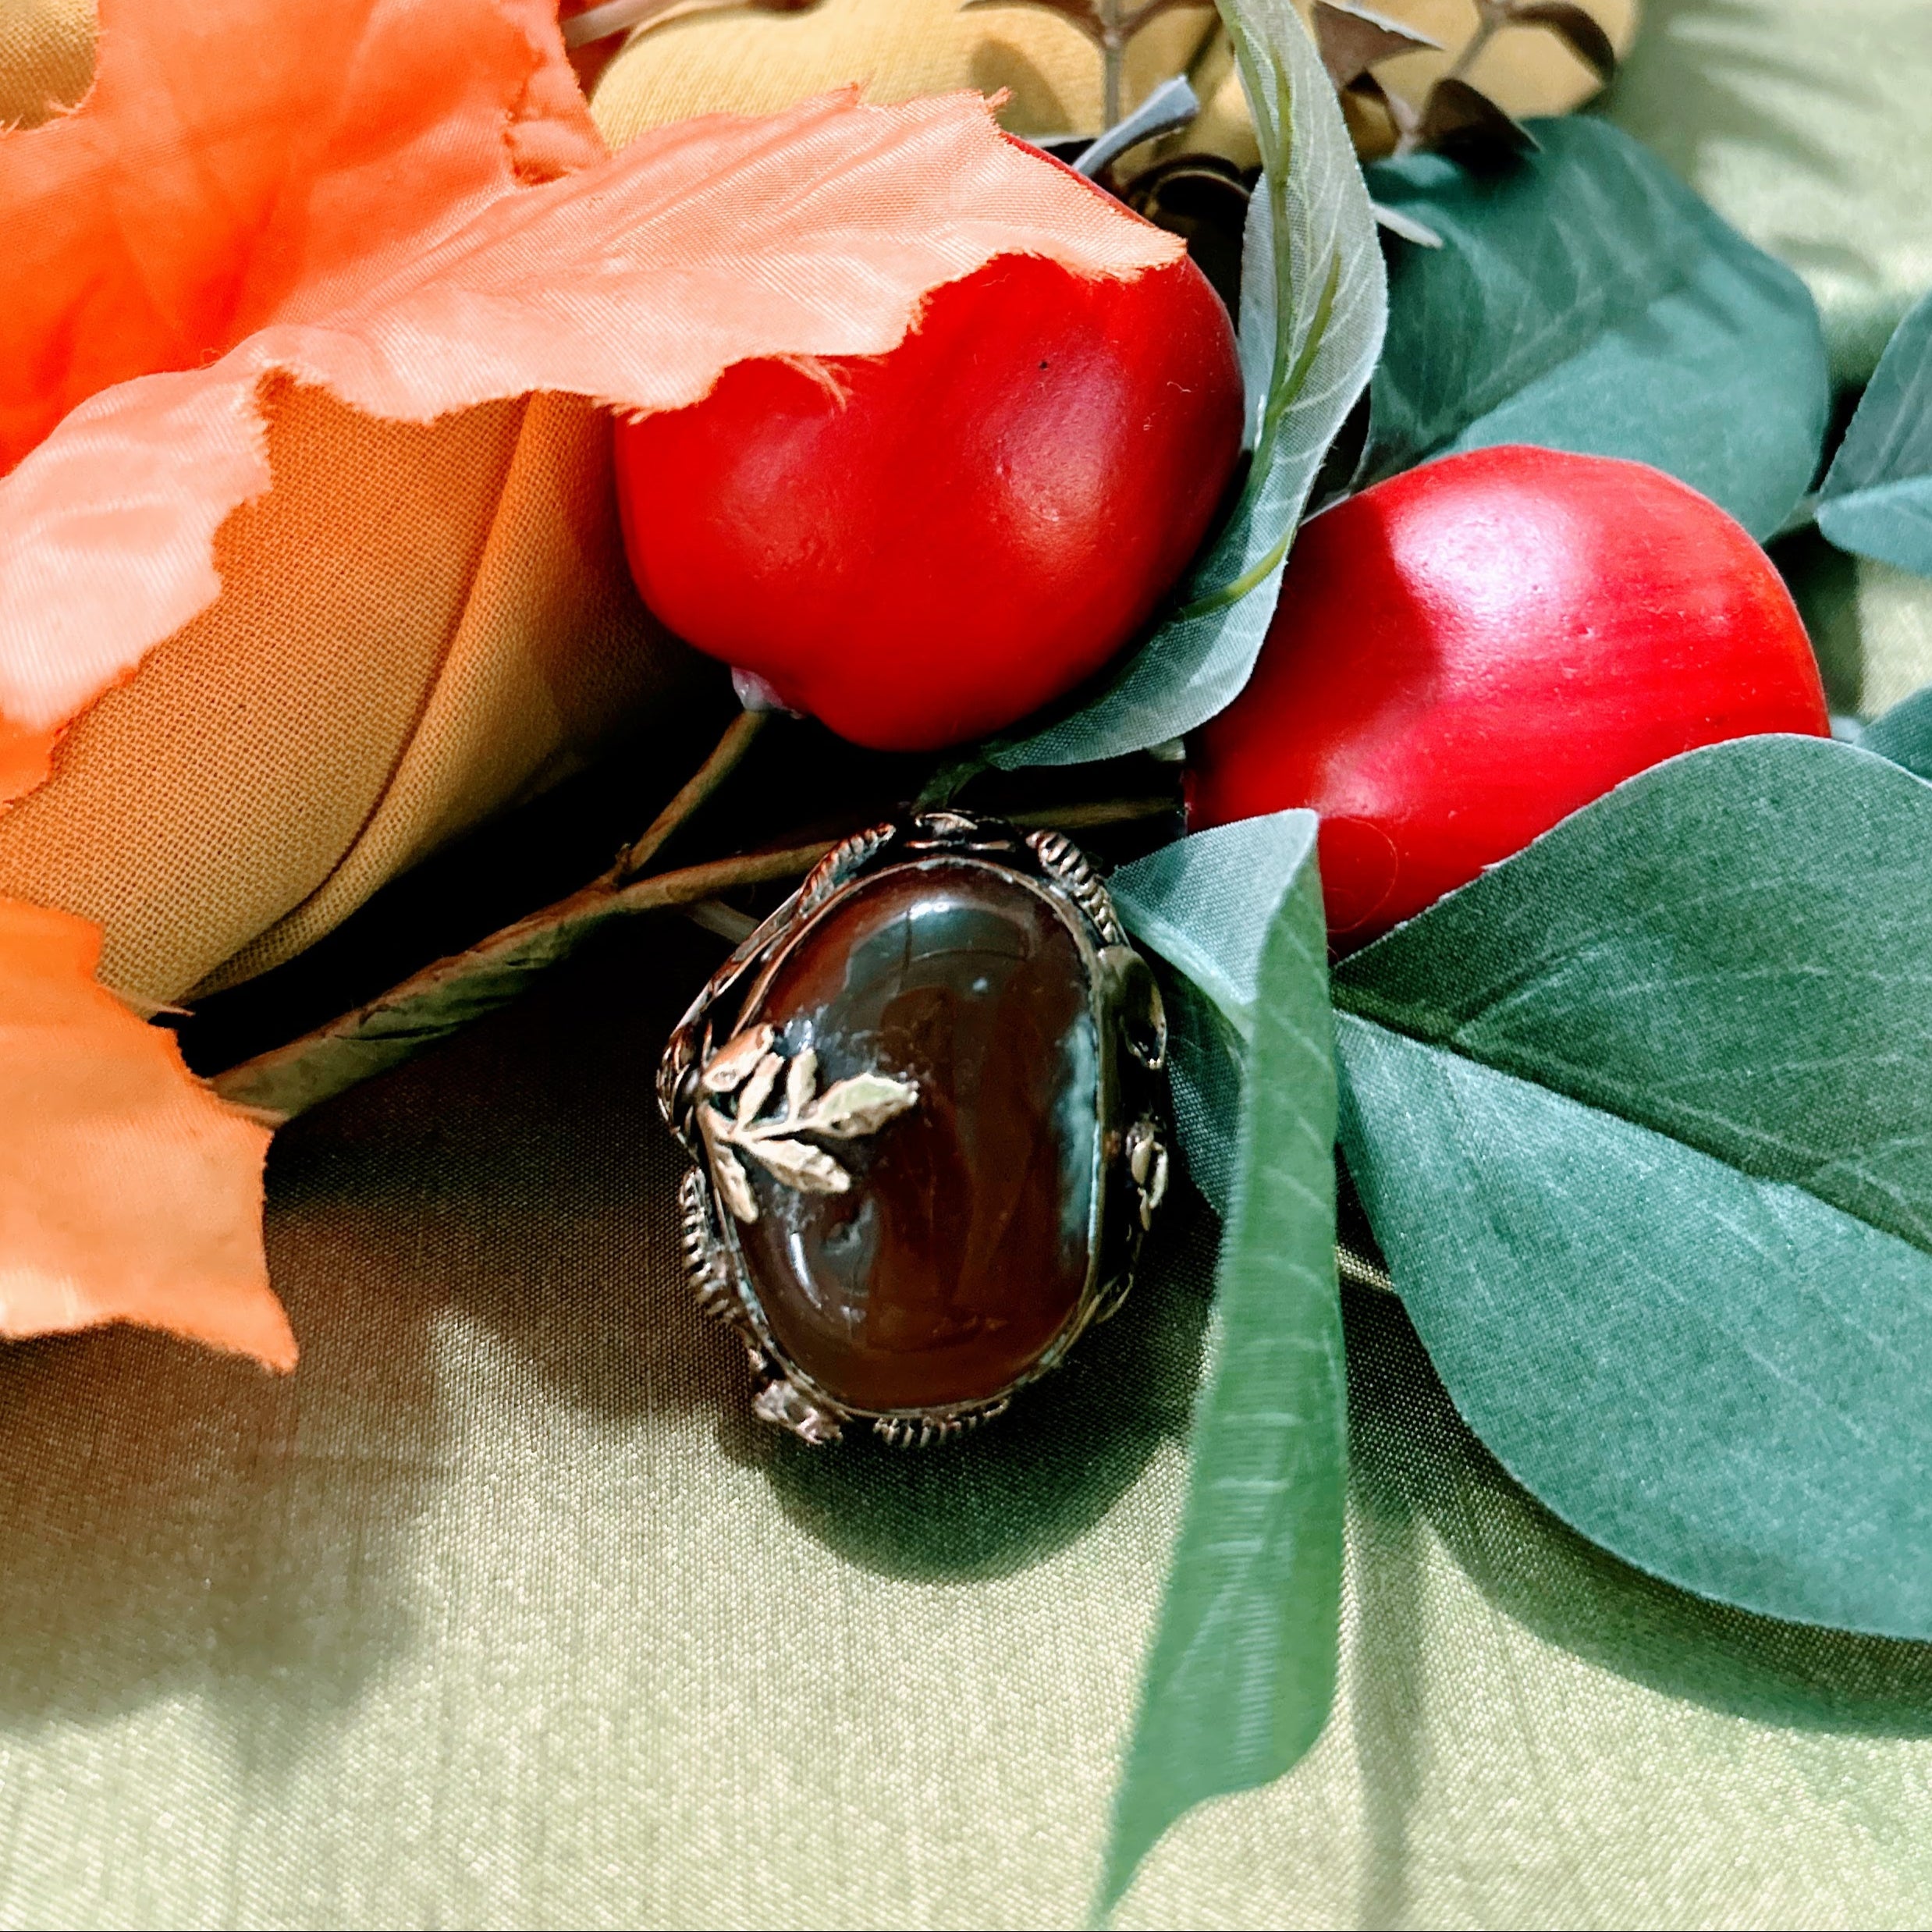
[738,858,1099,1410]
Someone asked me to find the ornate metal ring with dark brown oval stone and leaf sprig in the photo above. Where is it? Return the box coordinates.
[659,812,1169,1447]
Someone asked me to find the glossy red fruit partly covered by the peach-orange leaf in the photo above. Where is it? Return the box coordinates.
[616,243,1242,751]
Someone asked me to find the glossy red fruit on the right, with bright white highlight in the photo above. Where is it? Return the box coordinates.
[1188,446,1830,945]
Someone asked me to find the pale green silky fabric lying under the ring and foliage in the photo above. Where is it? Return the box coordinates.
[11,0,1932,1927]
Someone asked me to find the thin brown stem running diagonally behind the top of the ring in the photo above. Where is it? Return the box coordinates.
[211,792,1174,1120]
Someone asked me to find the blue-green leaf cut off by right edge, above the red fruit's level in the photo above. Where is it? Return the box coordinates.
[1818,283,1932,576]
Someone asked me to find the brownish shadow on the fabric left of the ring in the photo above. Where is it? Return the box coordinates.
[0,904,738,1775]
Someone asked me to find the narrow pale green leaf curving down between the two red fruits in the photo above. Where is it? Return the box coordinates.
[989,0,1387,767]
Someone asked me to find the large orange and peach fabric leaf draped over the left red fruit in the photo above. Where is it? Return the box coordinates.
[0,0,1181,800]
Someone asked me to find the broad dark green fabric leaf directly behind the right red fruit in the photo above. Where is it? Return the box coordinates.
[1364,118,1830,537]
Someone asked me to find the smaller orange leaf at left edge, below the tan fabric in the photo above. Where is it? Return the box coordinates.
[0,898,296,1369]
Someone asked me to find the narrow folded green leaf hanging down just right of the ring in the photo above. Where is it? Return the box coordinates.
[1101,812,1347,1912]
